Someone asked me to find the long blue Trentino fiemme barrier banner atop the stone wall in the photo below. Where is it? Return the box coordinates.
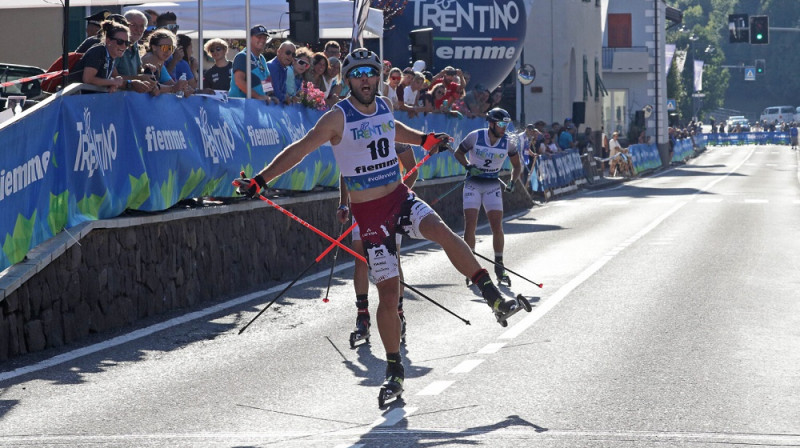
[0,92,486,270]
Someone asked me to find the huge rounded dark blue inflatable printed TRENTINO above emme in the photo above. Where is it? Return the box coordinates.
[380,0,533,89]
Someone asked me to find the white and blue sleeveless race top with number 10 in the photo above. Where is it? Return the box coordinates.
[332,97,400,191]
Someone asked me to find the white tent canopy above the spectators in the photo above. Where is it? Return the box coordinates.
[125,0,383,39]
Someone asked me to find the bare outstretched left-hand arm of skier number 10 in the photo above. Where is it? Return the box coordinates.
[258,109,344,183]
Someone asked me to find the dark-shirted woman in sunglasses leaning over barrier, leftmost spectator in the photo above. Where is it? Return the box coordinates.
[69,20,130,92]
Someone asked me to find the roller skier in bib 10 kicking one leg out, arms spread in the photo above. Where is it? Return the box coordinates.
[234,48,516,401]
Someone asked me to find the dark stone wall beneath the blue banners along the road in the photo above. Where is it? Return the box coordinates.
[0,178,532,360]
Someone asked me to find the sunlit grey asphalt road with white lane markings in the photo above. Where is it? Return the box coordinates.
[0,146,800,447]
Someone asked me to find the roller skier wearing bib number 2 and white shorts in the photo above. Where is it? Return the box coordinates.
[455,107,522,286]
